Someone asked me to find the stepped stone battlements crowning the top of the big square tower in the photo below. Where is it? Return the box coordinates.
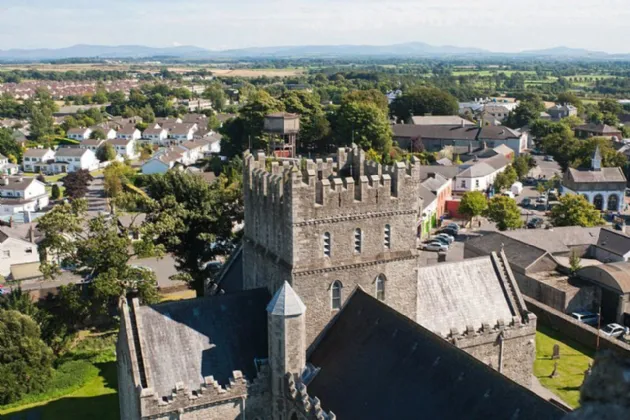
[244,146,420,213]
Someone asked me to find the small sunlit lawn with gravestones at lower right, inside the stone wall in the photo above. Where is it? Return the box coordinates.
[534,325,593,408]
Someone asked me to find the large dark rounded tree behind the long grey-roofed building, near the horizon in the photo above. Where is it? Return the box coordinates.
[390,86,459,122]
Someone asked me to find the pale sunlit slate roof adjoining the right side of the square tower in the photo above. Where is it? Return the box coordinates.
[417,256,520,336]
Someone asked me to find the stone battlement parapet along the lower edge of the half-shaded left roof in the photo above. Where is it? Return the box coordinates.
[140,367,269,416]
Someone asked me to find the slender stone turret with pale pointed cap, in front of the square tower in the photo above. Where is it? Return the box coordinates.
[267,282,306,419]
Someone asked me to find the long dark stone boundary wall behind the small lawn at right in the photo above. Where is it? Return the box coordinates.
[525,297,630,357]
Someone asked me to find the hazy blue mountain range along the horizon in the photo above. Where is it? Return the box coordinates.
[0,42,630,61]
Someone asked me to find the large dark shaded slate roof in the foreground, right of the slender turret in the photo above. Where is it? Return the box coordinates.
[308,289,564,420]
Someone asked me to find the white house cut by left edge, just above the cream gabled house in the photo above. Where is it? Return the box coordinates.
[0,176,49,215]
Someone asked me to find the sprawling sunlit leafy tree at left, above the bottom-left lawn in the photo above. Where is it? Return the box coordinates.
[37,199,167,311]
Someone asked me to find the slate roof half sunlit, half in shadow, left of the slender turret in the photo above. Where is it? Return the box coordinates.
[131,289,269,396]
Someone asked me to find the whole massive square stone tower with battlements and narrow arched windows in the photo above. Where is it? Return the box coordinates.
[243,146,421,345]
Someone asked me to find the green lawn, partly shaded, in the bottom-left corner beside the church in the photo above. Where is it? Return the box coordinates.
[0,332,119,420]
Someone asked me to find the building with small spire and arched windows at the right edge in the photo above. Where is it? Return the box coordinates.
[562,146,626,212]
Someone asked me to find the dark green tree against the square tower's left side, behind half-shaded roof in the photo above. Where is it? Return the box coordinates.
[133,167,243,296]
